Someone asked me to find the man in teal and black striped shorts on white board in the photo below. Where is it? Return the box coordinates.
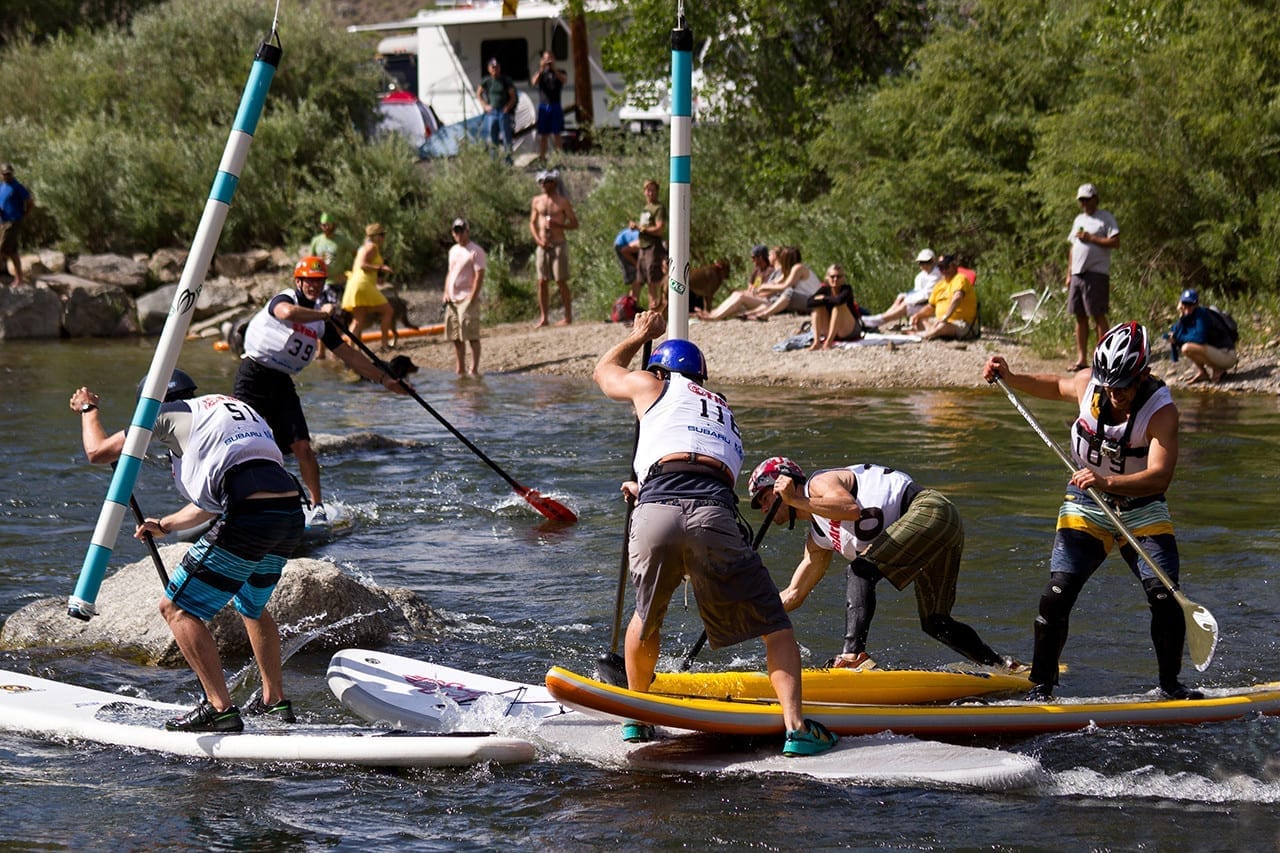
[70,370,305,733]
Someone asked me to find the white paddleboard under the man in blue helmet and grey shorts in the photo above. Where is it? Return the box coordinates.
[328,649,1043,790]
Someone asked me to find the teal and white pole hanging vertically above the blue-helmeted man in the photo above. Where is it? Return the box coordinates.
[667,3,694,341]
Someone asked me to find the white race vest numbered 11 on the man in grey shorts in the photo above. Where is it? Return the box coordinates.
[634,373,742,483]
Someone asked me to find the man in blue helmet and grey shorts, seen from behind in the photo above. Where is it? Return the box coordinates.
[593,311,838,756]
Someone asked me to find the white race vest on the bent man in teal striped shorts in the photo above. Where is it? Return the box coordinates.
[152,394,284,512]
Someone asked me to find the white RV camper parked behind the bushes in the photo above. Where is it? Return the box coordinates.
[348,0,668,138]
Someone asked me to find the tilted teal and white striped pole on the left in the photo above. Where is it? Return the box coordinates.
[67,34,283,621]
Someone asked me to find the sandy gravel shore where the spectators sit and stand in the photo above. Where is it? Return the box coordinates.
[381,307,1280,393]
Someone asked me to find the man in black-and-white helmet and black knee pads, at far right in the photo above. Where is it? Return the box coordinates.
[982,323,1204,701]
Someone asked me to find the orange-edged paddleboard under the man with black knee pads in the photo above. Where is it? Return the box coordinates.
[547,666,1280,736]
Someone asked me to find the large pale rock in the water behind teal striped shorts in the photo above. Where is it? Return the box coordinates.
[0,544,436,666]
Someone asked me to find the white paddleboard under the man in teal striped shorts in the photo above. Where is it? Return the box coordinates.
[0,670,534,767]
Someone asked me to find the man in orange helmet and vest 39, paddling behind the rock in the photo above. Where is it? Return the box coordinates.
[232,257,406,525]
